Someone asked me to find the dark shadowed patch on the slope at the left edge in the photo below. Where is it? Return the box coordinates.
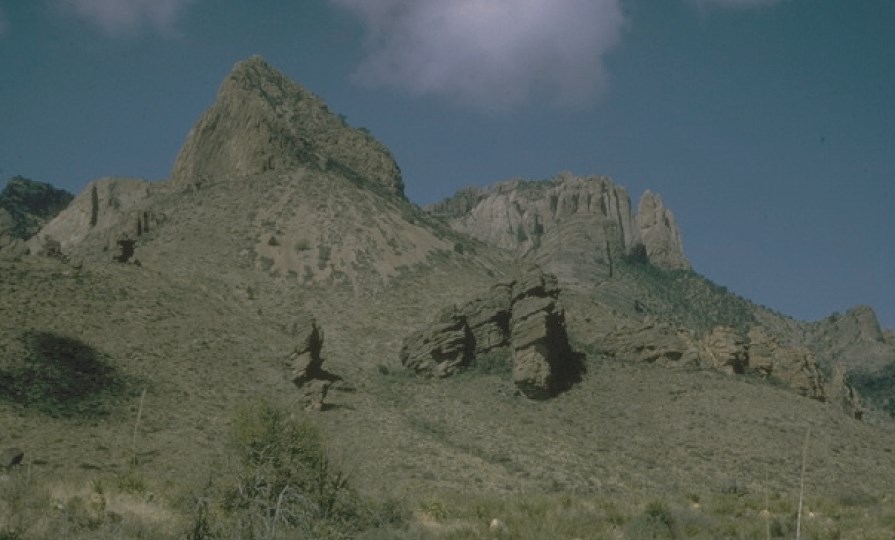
[0,332,127,417]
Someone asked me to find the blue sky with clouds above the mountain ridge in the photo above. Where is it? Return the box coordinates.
[0,0,895,328]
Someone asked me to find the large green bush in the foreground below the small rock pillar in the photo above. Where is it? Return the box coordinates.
[191,401,406,539]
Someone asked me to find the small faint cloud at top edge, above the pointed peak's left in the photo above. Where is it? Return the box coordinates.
[56,0,195,36]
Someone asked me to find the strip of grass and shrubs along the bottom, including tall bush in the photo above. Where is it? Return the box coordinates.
[0,401,895,540]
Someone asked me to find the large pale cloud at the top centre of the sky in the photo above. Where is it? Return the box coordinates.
[330,0,625,109]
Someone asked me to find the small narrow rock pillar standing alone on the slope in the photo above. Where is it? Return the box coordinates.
[287,313,342,411]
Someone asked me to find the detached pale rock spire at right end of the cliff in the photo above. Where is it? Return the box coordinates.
[637,190,690,269]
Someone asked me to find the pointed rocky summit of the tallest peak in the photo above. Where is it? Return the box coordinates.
[171,56,404,197]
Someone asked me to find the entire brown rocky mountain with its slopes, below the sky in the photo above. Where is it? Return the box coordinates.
[0,57,895,538]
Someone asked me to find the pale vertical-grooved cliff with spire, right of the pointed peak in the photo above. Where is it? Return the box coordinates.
[428,175,690,279]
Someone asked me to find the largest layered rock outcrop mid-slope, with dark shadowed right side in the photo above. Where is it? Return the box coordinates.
[400,269,582,399]
